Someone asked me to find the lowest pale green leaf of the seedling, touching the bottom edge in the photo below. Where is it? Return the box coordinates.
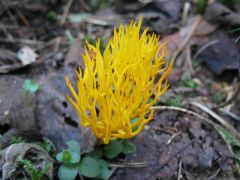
[58,164,79,180]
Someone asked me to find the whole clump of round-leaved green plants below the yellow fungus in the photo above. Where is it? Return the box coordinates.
[56,140,136,180]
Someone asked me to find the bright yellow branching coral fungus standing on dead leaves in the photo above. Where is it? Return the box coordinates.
[66,20,172,144]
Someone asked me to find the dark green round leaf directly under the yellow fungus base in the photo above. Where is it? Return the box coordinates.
[104,140,123,159]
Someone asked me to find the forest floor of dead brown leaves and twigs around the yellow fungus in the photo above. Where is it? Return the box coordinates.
[0,0,240,180]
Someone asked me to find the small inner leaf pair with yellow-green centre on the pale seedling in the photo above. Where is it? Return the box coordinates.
[56,150,80,164]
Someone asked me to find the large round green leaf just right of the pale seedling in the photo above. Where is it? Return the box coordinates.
[79,157,101,178]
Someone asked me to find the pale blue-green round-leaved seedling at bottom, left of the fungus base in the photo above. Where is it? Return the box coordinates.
[56,140,112,180]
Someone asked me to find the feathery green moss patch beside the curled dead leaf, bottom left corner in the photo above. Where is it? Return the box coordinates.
[20,159,50,180]
